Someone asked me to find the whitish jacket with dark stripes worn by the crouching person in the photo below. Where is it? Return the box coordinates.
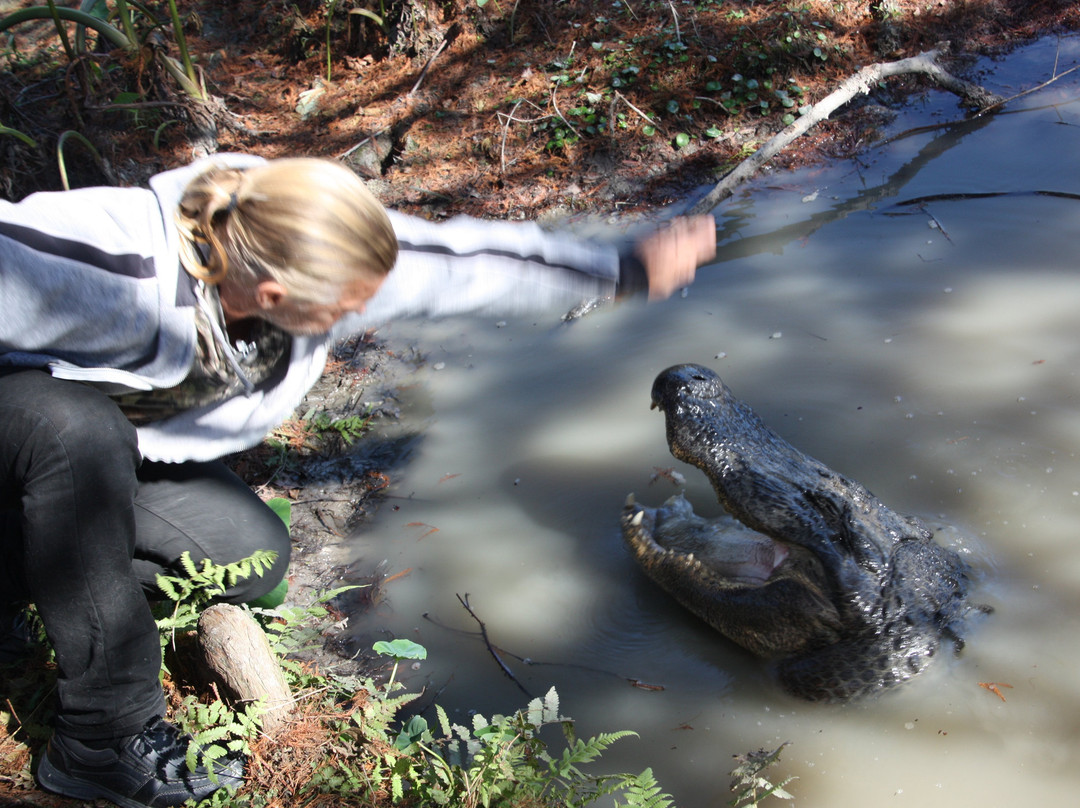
[0,154,626,462]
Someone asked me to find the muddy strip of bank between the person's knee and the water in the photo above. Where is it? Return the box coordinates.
[227,334,423,666]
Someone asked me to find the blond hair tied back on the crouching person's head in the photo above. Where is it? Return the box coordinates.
[176,158,397,304]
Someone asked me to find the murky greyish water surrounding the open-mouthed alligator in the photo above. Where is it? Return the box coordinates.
[343,38,1080,808]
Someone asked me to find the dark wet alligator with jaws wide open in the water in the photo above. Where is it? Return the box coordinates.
[621,365,987,701]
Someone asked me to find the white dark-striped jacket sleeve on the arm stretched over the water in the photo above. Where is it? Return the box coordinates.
[335,211,642,336]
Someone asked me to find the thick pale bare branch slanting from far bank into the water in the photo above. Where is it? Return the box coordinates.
[690,45,1003,214]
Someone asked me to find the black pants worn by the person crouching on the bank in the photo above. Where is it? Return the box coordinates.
[0,371,289,740]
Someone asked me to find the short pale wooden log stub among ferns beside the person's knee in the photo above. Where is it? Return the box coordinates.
[199,604,293,732]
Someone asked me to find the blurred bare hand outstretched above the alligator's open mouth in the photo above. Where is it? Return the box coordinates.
[634,215,716,300]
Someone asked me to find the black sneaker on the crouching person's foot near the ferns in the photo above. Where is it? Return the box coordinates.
[38,717,244,808]
